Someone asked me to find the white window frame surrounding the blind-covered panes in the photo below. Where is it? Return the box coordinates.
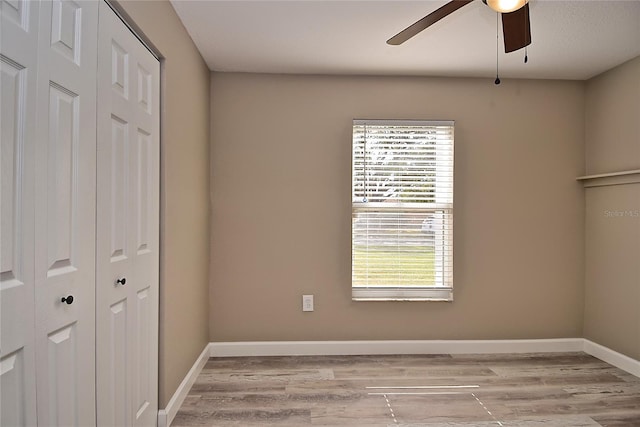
[351,119,455,301]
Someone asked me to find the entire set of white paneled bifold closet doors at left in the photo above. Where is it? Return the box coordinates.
[0,0,160,427]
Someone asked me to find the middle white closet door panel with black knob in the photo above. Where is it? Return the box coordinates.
[32,0,98,426]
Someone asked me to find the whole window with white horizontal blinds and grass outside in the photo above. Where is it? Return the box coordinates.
[351,120,454,301]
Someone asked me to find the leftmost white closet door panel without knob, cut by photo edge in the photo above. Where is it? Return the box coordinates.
[0,0,38,426]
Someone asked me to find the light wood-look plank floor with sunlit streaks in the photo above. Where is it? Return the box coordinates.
[172,353,640,427]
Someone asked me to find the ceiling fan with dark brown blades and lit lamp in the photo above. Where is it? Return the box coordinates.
[387,0,531,53]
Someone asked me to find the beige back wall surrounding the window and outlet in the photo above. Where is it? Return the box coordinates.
[209,73,585,341]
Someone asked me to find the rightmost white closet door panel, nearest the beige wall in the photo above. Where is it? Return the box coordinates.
[96,3,160,426]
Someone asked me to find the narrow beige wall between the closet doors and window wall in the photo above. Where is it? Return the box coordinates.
[111,0,210,408]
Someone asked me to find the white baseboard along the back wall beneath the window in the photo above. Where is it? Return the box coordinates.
[209,338,584,357]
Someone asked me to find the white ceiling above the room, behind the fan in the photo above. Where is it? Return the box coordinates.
[171,0,640,80]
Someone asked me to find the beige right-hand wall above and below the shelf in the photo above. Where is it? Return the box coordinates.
[584,57,640,360]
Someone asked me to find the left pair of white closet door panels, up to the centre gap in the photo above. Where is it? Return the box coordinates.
[0,0,98,426]
